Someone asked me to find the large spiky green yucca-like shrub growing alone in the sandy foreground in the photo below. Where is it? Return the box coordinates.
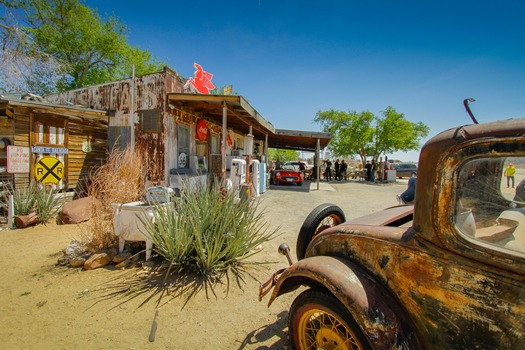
[146,180,277,277]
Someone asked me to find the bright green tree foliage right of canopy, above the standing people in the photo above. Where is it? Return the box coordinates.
[314,106,429,164]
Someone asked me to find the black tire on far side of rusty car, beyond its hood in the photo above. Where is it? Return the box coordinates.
[295,203,346,260]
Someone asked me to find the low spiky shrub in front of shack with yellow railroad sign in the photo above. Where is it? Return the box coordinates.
[2,181,61,224]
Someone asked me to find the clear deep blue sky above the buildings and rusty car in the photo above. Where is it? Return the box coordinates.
[85,0,525,161]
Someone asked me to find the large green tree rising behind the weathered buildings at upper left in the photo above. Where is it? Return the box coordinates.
[0,0,163,94]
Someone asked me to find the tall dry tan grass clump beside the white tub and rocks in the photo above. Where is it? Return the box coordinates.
[82,148,146,251]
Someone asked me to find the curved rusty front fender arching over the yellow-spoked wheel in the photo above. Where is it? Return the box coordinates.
[268,256,420,349]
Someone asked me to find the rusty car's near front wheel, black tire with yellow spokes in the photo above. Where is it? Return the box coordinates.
[288,289,370,349]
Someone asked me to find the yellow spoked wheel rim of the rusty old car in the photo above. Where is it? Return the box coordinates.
[297,308,362,350]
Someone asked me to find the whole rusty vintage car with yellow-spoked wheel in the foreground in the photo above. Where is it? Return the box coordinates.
[259,119,525,349]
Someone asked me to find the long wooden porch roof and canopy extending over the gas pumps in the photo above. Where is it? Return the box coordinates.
[168,93,332,152]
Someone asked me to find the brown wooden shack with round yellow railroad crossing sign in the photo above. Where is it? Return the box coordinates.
[0,96,108,191]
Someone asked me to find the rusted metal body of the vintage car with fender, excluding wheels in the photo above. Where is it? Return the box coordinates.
[265,119,525,349]
